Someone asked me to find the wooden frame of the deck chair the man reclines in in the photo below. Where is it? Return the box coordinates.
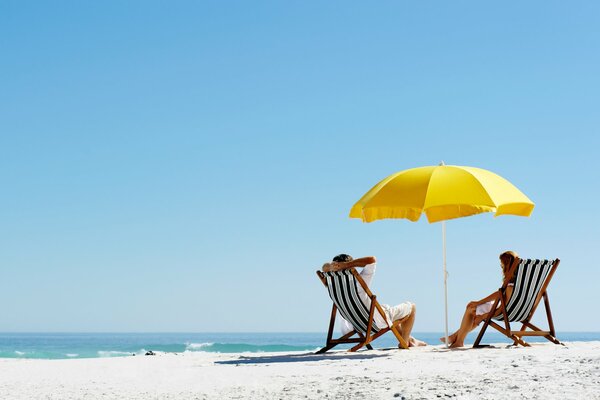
[316,268,410,354]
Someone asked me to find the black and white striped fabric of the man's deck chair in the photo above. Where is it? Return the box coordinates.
[323,270,381,334]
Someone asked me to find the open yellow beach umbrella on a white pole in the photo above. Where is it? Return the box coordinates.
[350,163,535,342]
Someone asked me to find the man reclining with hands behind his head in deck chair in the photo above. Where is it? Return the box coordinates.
[322,254,427,347]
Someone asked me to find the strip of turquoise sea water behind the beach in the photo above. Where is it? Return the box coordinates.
[0,332,600,359]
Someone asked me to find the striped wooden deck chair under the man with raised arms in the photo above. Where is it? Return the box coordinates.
[317,268,408,354]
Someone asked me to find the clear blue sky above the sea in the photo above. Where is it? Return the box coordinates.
[0,1,600,331]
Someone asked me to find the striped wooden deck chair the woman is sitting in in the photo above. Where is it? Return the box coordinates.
[473,258,561,347]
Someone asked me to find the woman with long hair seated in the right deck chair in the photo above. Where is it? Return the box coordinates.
[440,251,519,348]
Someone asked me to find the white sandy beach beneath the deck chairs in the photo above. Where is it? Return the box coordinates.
[0,342,600,400]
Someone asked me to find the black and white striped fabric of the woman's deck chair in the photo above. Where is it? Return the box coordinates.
[494,259,556,322]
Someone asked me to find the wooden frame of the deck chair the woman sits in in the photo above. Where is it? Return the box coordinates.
[473,258,562,348]
